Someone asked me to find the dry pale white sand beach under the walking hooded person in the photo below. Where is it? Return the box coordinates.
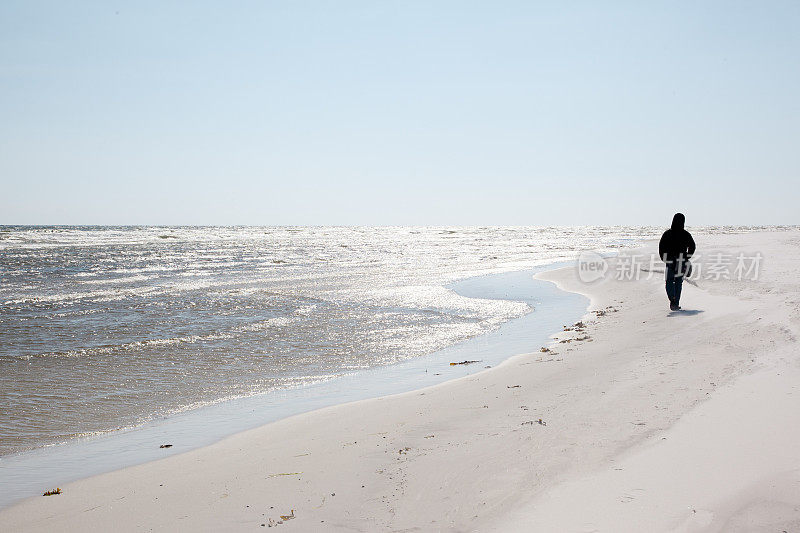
[0,232,800,532]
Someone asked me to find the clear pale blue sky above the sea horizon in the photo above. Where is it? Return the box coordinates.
[0,0,800,225]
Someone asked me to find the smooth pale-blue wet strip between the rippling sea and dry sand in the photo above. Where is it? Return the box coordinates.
[0,263,585,510]
